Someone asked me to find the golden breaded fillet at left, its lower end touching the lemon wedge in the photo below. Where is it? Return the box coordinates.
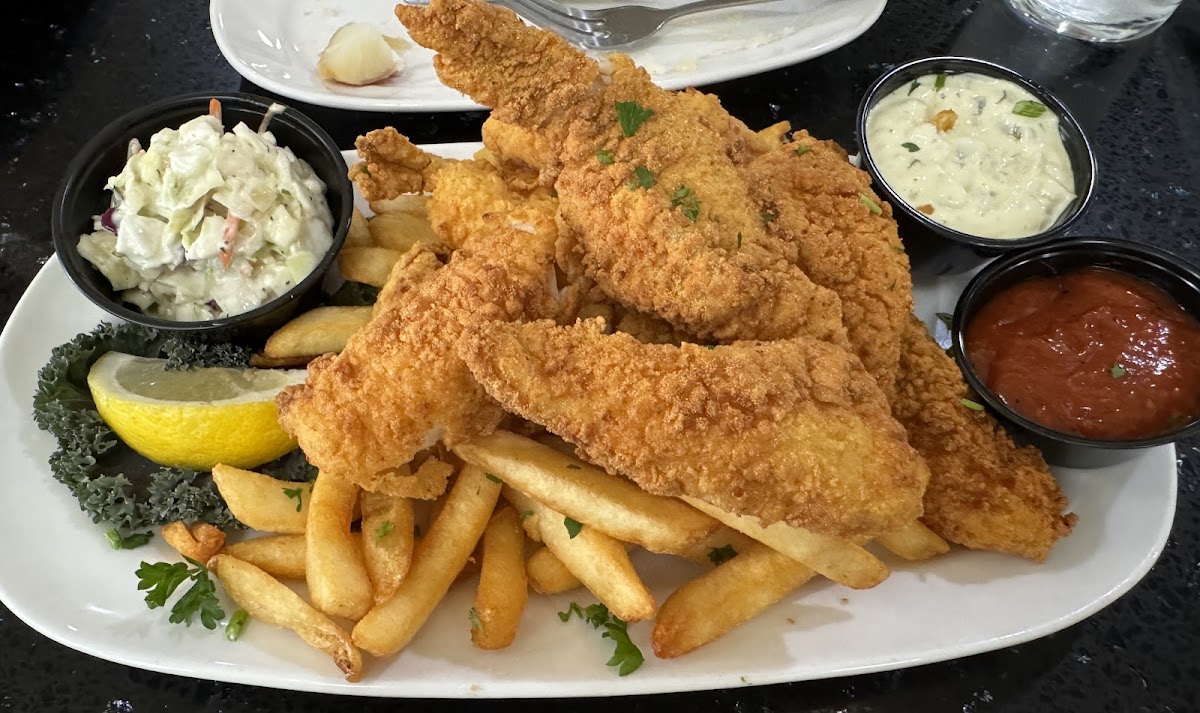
[277,211,560,493]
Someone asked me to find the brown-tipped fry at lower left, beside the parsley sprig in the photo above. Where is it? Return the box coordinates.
[208,555,362,683]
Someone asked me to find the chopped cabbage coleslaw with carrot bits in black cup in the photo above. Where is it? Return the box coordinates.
[78,110,334,322]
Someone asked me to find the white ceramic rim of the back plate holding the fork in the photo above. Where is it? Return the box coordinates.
[209,0,887,112]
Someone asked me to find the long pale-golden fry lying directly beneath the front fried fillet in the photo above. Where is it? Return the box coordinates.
[454,431,720,553]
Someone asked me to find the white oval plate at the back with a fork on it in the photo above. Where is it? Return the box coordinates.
[209,0,886,112]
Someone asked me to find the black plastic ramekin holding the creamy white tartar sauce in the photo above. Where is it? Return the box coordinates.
[856,56,1096,275]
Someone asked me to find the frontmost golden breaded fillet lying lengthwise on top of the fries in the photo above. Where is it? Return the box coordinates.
[458,320,929,538]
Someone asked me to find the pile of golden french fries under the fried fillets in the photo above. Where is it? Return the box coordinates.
[162,196,948,681]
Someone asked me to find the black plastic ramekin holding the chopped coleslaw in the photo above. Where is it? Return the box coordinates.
[50,92,354,338]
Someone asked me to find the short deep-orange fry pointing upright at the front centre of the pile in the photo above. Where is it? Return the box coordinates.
[470,507,529,651]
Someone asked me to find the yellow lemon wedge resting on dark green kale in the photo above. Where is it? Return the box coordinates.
[88,352,307,471]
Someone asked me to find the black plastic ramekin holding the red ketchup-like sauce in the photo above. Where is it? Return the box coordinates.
[950,238,1200,467]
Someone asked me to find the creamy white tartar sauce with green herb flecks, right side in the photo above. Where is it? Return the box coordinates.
[866,73,1075,238]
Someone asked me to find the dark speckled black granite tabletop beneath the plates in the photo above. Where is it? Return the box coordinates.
[0,0,1200,713]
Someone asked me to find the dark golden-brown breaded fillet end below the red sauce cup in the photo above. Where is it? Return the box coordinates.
[893,317,1076,562]
